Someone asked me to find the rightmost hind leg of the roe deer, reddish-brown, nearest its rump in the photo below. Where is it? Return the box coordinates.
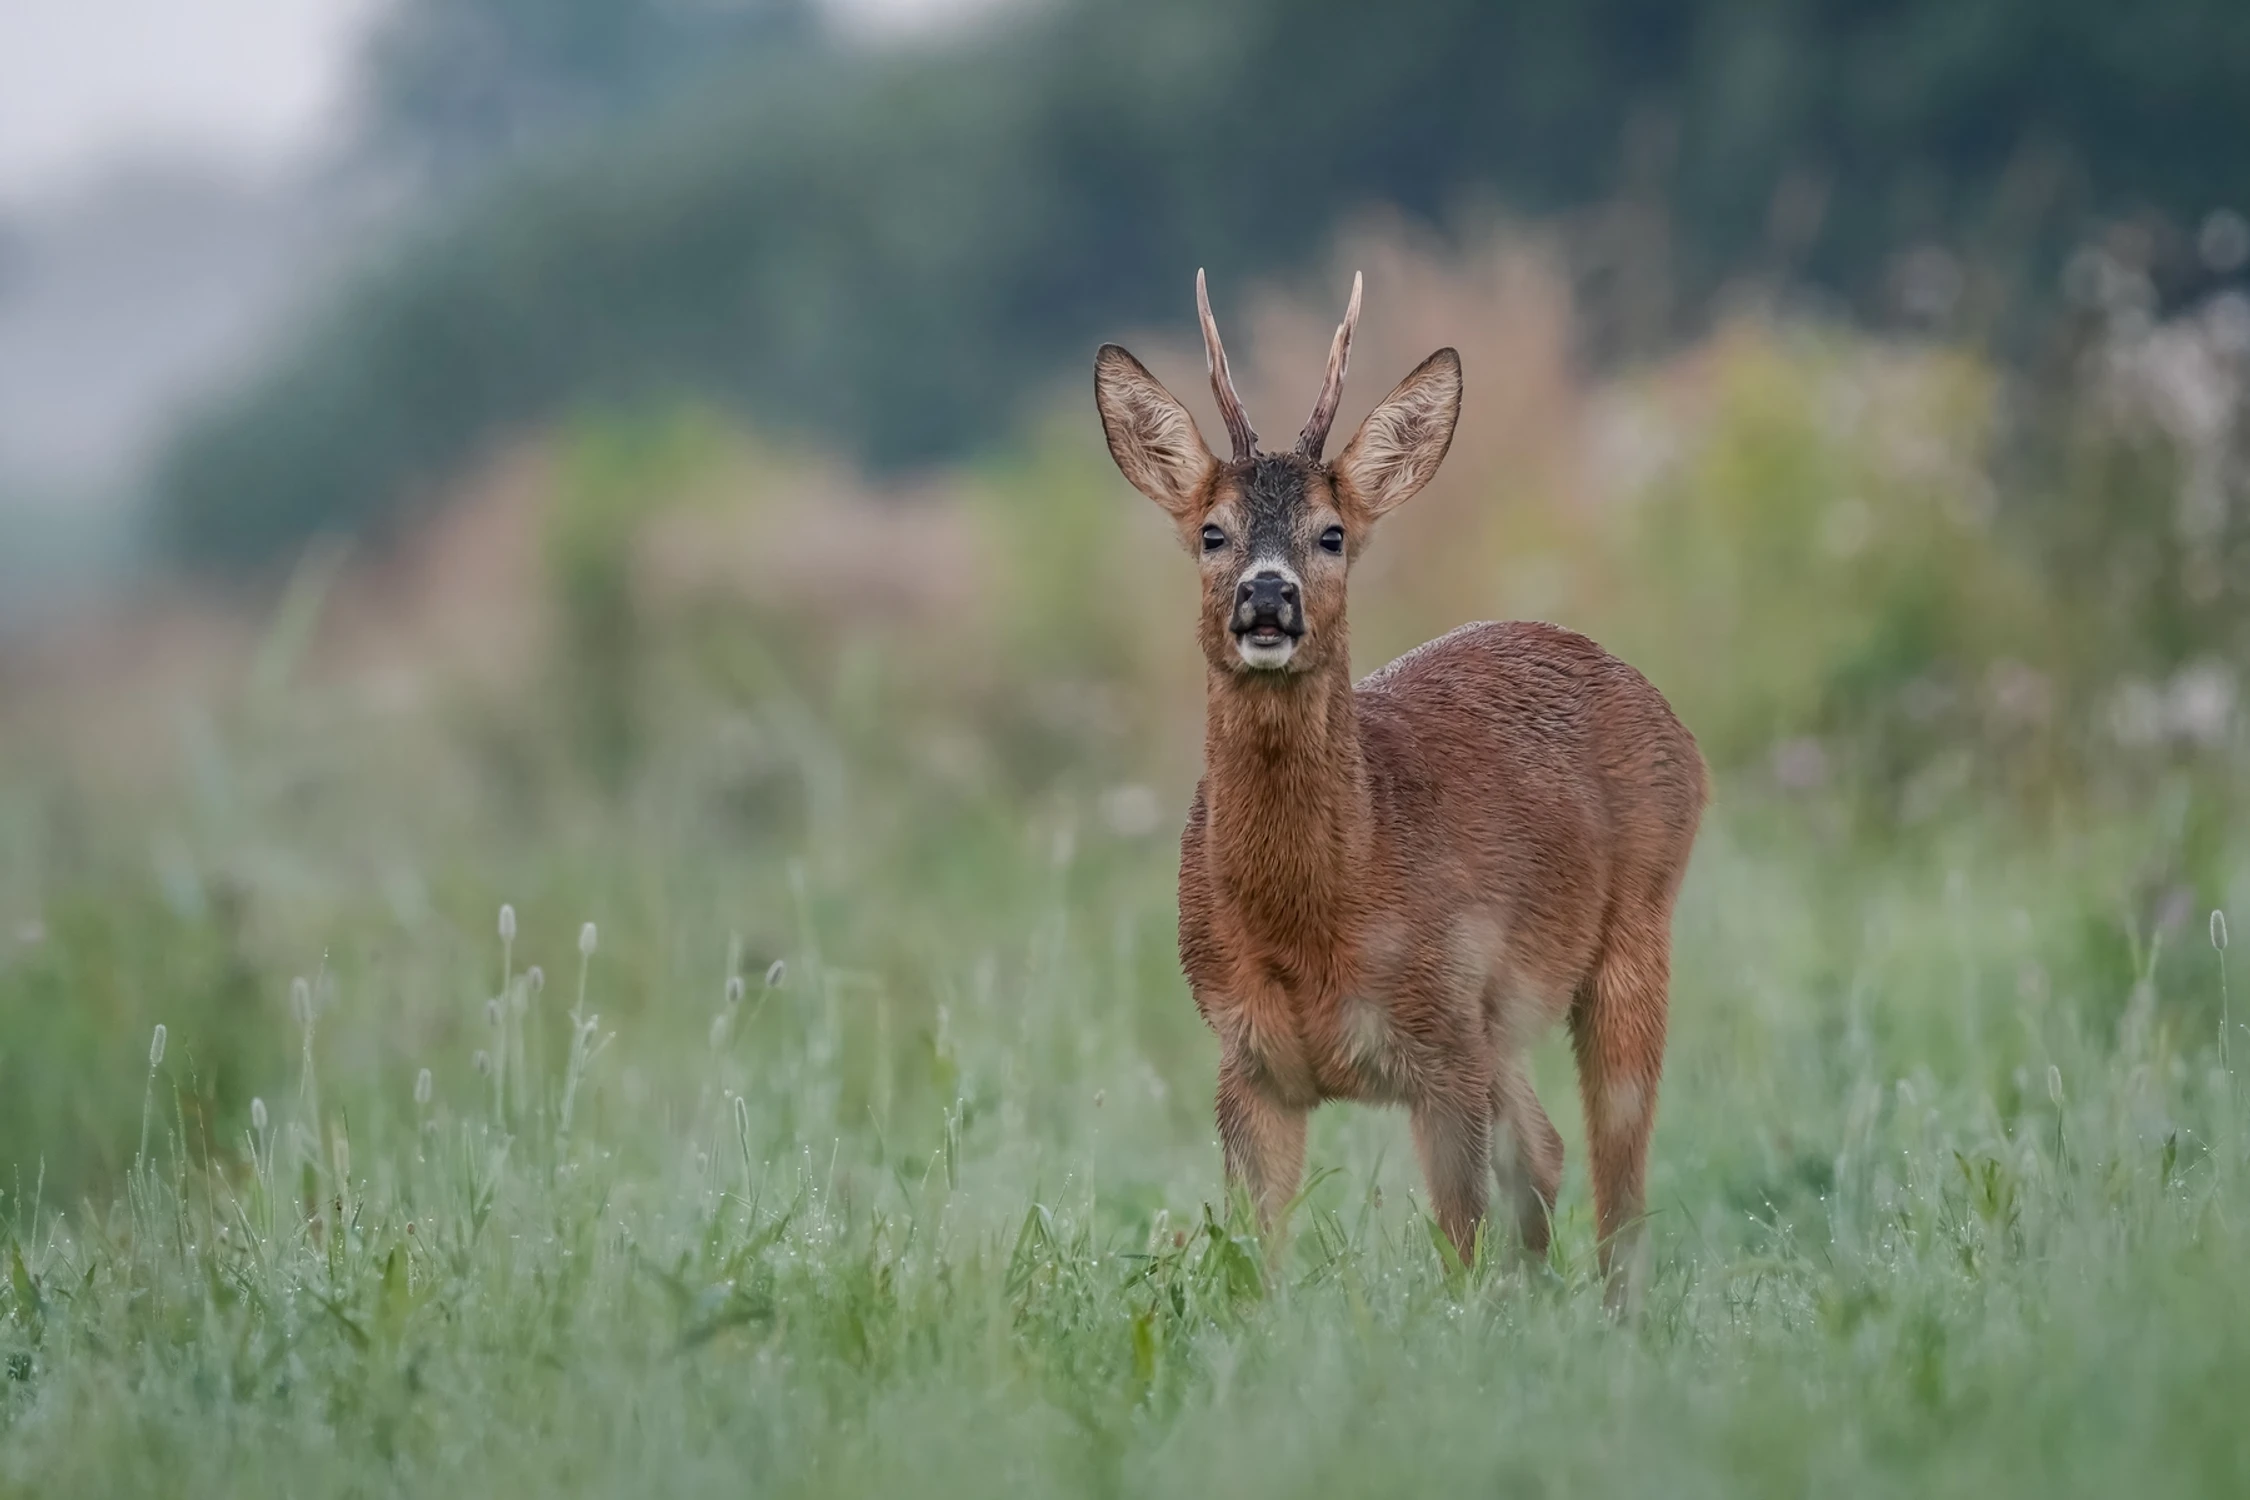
[1571,911,1672,1307]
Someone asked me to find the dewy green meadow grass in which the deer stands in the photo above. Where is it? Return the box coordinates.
[0,746,2250,1496]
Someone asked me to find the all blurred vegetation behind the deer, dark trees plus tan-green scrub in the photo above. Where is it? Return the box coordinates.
[0,0,2250,1250]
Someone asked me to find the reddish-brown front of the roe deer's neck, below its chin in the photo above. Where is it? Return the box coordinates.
[1204,650,1373,949]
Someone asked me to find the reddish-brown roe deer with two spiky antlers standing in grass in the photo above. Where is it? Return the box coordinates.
[1094,272,1708,1298]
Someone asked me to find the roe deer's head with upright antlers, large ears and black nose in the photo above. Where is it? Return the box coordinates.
[1094,272,1460,679]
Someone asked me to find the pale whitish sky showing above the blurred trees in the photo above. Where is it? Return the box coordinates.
[0,0,988,209]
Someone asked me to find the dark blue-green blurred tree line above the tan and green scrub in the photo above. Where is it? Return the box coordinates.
[158,0,2250,562]
